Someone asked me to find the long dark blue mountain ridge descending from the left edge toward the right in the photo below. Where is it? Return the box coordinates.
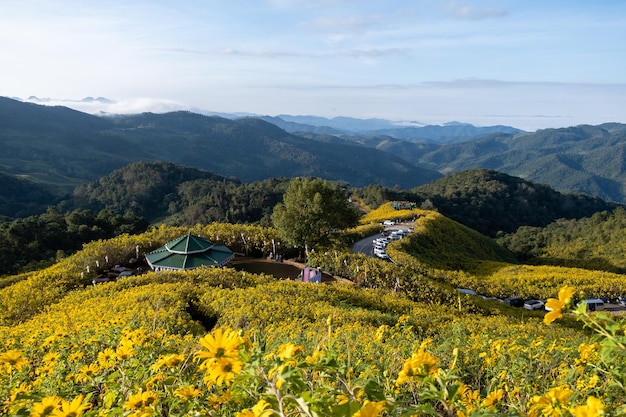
[0,97,441,191]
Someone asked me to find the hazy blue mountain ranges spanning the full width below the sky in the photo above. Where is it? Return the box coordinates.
[0,98,626,203]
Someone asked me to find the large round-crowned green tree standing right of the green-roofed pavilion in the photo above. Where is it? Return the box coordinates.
[272,178,359,256]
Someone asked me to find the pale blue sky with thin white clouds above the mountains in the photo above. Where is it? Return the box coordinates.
[0,0,626,131]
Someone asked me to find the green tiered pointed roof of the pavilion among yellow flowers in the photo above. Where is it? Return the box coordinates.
[146,233,235,271]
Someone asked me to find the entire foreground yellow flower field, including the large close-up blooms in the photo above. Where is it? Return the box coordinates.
[0,269,626,417]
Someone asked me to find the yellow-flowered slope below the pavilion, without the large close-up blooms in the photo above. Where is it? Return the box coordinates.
[0,260,586,416]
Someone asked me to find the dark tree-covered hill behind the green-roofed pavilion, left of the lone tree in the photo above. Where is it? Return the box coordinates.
[69,162,289,226]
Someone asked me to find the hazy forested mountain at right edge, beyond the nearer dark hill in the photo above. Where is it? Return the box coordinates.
[414,123,626,203]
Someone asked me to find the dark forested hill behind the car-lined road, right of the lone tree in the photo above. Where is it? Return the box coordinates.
[354,169,621,237]
